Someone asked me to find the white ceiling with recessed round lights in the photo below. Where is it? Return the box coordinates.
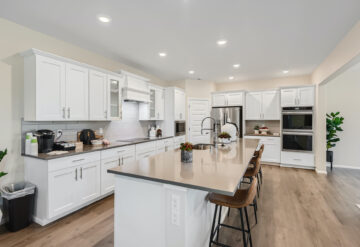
[0,0,360,82]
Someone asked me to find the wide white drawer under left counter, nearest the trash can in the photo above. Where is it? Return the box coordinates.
[48,152,100,172]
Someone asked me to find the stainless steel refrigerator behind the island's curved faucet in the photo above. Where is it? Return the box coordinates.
[211,106,243,140]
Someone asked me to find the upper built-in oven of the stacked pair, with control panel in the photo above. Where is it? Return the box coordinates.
[282,107,313,132]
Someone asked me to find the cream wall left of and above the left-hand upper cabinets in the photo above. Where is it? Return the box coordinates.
[0,18,166,184]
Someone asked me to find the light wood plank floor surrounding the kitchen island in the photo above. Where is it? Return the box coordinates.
[0,166,360,247]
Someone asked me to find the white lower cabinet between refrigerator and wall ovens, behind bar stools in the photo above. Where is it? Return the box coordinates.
[245,136,281,163]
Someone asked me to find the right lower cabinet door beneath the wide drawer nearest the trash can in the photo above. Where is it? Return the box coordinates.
[78,161,100,204]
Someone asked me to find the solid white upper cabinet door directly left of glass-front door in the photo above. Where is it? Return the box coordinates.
[89,70,108,120]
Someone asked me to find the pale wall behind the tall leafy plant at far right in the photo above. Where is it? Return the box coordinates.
[325,63,360,169]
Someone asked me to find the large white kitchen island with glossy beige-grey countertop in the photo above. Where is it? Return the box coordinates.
[108,139,258,247]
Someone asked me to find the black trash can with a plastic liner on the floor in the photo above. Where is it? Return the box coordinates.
[1,182,35,232]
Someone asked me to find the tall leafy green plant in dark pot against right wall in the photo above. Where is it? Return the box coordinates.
[326,112,344,170]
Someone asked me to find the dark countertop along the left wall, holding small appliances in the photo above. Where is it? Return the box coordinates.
[22,136,173,160]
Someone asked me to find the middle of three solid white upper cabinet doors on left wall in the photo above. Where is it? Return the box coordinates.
[66,64,89,120]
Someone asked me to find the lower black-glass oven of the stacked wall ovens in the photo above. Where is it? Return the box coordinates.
[282,131,313,152]
